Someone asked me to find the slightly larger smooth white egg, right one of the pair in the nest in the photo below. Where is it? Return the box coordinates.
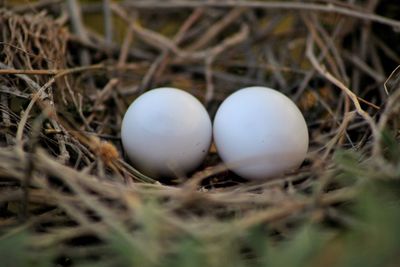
[213,86,309,179]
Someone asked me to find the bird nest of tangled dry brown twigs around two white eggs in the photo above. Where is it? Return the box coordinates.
[0,1,400,266]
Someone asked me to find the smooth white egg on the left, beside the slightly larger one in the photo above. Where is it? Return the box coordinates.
[121,87,212,178]
